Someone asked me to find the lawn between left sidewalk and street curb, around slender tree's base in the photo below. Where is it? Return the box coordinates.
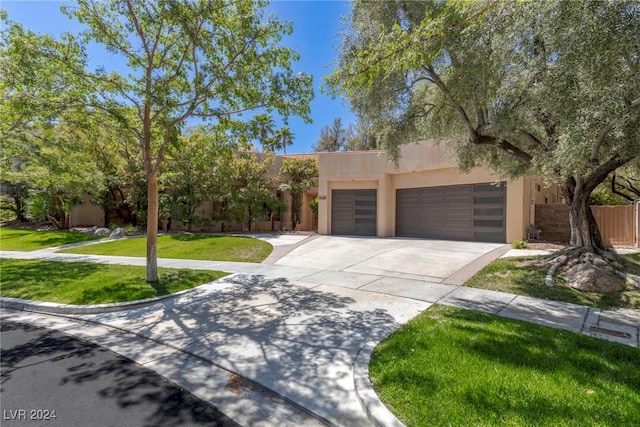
[0,259,228,304]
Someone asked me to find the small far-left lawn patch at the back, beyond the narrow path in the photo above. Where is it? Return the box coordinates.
[0,227,99,252]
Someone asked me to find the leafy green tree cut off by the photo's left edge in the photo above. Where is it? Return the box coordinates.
[0,9,89,226]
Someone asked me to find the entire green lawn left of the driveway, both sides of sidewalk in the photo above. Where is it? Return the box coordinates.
[0,227,272,304]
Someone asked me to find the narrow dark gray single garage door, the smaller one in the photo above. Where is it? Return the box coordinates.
[331,190,377,236]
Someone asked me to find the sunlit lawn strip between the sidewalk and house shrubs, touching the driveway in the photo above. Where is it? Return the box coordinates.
[59,234,273,262]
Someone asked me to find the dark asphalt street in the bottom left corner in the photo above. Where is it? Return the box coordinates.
[0,322,238,427]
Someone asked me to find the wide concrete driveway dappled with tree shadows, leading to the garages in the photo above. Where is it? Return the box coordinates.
[1,236,513,426]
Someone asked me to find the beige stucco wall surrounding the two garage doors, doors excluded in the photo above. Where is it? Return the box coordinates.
[318,142,531,242]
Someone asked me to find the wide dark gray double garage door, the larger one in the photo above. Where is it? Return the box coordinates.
[396,184,506,242]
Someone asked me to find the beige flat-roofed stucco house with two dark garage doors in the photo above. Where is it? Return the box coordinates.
[72,141,640,245]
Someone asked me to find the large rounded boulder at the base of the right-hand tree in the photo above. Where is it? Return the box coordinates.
[563,263,626,294]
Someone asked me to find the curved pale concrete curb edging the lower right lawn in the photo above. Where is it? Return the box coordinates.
[353,341,405,427]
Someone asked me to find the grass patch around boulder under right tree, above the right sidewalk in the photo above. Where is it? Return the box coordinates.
[465,254,640,309]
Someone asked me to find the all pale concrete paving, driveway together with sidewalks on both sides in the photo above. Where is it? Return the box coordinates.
[0,236,640,426]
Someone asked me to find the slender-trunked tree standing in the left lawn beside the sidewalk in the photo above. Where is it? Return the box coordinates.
[64,0,313,282]
